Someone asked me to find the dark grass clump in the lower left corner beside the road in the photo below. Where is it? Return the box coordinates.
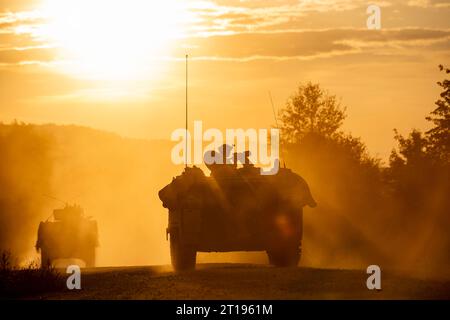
[0,251,65,299]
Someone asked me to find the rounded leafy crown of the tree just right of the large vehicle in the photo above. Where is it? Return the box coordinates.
[280,82,346,143]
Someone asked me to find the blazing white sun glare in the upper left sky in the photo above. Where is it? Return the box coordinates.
[37,0,187,80]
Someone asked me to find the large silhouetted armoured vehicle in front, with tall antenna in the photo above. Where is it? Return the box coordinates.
[159,147,316,270]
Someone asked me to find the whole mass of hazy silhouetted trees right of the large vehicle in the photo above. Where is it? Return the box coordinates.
[281,76,450,273]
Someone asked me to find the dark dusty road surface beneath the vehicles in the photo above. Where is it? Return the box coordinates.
[36,264,450,299]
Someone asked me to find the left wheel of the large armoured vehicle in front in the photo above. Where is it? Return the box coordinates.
[170,231,197,271]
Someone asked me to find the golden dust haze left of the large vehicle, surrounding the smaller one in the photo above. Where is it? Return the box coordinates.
[0,124,179,266]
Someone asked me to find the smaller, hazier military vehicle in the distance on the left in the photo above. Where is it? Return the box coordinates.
[36,205,98,267]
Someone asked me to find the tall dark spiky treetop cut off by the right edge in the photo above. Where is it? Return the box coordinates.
[426,65,450,164]
